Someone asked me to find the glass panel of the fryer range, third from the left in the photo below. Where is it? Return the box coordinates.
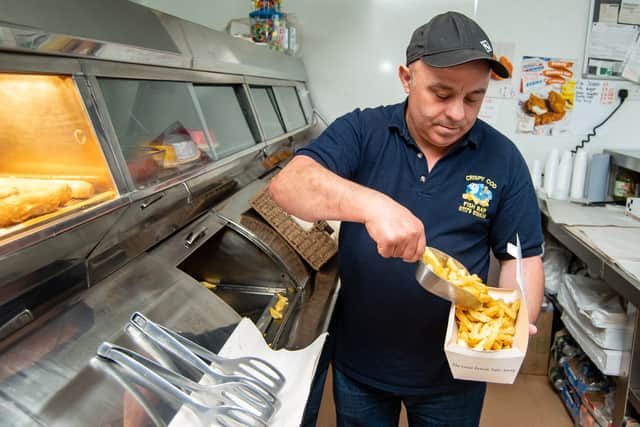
[195,85,256,158]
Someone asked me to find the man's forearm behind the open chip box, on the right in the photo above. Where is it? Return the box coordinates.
[499,256,544,324]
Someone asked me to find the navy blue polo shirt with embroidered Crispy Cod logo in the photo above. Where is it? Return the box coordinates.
[297,102,543,394]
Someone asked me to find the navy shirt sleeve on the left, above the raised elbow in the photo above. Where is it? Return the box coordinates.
[296,110,362,179]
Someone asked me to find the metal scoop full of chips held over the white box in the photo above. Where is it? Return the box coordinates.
[416,247,480,308]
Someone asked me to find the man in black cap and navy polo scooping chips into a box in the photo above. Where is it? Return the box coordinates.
[269,12,543,426]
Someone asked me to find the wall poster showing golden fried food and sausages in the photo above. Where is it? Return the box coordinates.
[516,56,576,136]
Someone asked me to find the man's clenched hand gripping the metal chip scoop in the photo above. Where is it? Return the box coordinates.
[364,193,426,262]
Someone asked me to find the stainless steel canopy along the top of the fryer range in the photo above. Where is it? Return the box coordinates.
[0,0,306,81]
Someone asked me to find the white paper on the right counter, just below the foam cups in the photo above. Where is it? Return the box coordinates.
[546,199,640,227]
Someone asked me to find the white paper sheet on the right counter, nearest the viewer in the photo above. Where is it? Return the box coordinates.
[568,227,640,262]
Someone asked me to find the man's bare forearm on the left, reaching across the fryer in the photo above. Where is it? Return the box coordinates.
[269,156,386,222]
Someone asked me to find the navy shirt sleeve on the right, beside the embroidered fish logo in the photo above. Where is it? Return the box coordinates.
[490,147,544,260]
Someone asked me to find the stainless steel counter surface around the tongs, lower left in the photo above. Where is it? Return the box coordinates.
[0,255,240,426]
